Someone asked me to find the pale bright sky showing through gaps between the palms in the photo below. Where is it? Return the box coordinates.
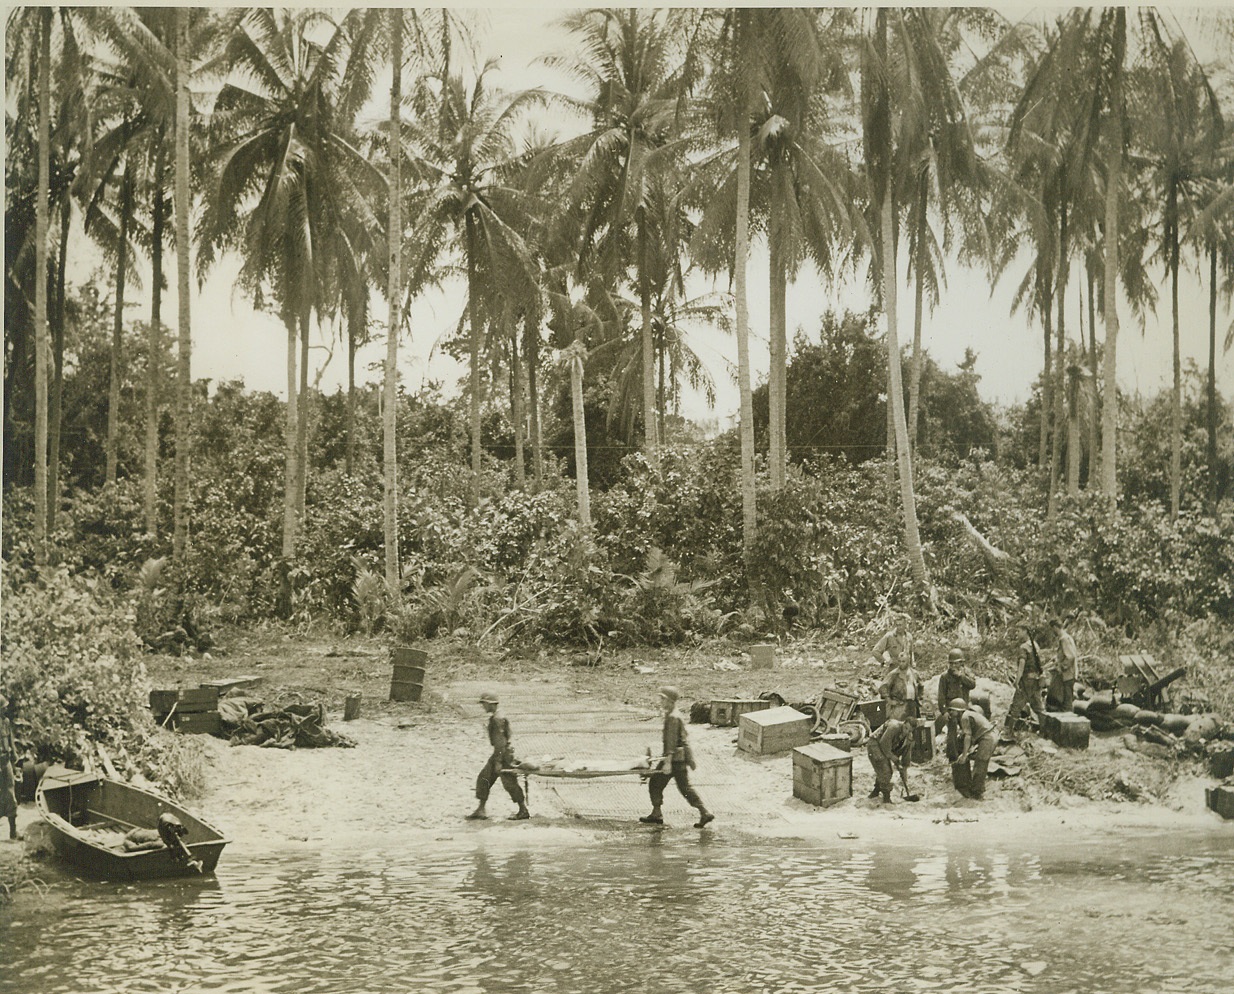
[67,5,1234,428]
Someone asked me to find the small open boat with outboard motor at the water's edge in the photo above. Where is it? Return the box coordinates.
[35,767,227,881]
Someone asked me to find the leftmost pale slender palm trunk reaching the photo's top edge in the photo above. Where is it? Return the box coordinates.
[35,7,52,566]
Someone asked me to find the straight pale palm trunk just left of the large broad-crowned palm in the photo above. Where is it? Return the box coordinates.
[172,7,193,559]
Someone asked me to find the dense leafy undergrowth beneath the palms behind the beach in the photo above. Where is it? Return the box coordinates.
[0,382,1234,791]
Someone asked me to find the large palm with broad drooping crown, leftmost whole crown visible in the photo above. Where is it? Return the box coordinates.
[202,9,375,560]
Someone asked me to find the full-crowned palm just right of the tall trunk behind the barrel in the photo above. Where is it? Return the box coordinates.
[407,62,537,504]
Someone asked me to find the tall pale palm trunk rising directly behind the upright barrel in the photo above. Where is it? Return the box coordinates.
[381,7,402,598]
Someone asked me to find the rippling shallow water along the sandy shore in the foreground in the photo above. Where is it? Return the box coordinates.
[0,830,1234,994]
